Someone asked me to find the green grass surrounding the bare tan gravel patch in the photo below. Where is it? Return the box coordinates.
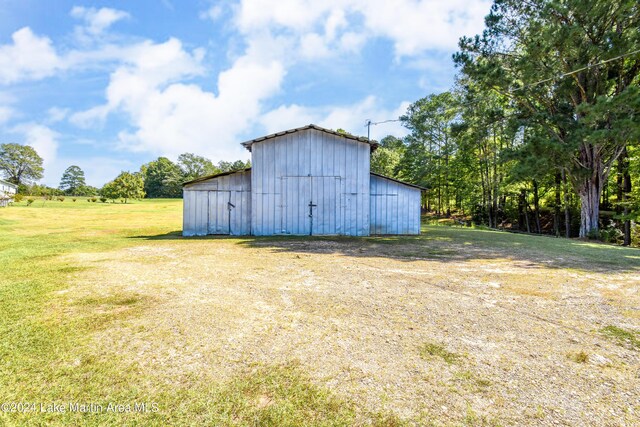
[0,199,640,426]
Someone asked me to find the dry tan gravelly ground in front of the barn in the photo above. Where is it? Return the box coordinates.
[62,234,640,426]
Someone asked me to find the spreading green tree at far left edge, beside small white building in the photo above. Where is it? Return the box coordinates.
[0,144,44,185]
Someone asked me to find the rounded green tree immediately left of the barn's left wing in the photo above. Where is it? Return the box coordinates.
[140,157,183,198]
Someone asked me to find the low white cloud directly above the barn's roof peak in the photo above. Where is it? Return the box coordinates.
[260,96,409,140]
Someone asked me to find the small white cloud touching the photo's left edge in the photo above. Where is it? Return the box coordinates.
[0,27,63,84]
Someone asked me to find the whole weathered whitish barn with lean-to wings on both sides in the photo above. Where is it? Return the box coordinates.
[183,125,422,236]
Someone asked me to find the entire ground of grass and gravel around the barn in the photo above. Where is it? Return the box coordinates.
[0,200,640,426]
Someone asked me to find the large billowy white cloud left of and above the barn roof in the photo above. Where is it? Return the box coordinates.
[71,39,284,160]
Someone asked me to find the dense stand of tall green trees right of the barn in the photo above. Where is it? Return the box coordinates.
[372,0,640,245]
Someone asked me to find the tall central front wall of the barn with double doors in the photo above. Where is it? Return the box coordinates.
[251,129,370,236]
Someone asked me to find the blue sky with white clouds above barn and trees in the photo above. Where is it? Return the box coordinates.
[0,0,490,186]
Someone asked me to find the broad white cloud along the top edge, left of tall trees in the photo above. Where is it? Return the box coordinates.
[236,0,491,58]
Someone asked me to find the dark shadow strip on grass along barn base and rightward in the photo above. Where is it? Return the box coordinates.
[133,226,640,272]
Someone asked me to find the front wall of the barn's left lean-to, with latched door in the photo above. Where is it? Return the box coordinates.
[182,171,251,236]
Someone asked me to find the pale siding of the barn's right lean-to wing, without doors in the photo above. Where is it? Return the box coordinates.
[371,175,420,234]
